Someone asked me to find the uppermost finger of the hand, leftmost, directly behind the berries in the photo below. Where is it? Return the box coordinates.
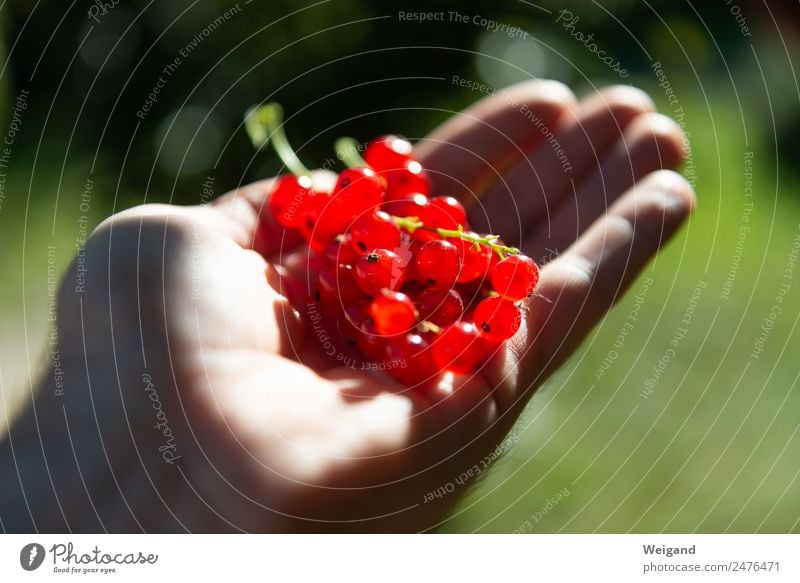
[417,80,575,204]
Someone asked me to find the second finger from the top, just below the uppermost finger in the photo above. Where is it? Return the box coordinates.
[470,85,655,244]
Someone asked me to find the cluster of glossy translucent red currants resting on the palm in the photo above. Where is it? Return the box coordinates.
[253,110,539,385]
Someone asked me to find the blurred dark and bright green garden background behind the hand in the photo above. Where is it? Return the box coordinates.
[0,0,800,532]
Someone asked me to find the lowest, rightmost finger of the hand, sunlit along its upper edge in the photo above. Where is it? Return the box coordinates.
[515,171,695,392]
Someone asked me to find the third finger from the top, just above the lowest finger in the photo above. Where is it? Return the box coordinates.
[522,113,685,259]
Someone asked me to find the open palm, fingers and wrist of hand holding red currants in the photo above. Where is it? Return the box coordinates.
[0,81,695,532]
